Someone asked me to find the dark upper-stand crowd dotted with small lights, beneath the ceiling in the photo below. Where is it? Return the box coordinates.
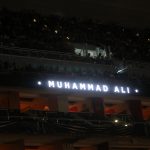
[0,9,150,63]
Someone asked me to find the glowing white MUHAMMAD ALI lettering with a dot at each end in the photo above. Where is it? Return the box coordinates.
[37,80,139,94]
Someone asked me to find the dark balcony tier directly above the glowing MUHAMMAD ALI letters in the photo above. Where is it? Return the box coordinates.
[0,46,150,96]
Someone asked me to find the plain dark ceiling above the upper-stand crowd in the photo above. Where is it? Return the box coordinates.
[0,0,150,27]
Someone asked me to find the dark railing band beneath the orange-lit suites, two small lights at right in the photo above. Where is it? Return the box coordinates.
[0,109,150,136]
